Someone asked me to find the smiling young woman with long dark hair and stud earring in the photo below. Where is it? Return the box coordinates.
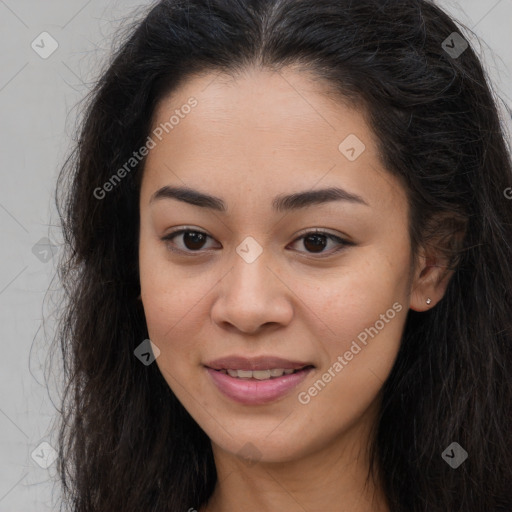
[53,0,512,512]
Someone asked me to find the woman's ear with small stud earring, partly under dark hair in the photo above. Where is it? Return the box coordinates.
[409,213,466,312]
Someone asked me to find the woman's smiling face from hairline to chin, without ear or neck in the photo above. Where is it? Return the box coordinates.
[139,70,411,468]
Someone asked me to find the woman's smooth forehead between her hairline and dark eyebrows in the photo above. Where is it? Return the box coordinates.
[143,69,404,214]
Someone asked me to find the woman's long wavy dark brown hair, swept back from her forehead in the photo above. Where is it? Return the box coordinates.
[55,0,512,512]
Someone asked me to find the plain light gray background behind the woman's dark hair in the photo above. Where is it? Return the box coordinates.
[0,0,512,512]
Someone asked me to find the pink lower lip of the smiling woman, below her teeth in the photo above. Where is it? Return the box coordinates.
[206,368,314,405]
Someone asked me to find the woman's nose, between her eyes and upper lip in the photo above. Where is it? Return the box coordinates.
[211,251,293,334]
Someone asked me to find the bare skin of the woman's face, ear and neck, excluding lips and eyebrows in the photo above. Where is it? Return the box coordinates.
[139,68,454,512]
